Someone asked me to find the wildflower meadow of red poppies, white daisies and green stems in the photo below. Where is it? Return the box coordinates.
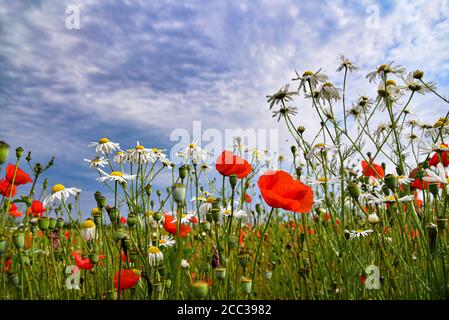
[0,56,449,300]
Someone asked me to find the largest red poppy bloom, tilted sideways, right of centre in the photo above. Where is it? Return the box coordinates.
[257,170,313,213]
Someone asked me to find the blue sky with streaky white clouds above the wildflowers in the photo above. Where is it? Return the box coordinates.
[0,0,449,218]
